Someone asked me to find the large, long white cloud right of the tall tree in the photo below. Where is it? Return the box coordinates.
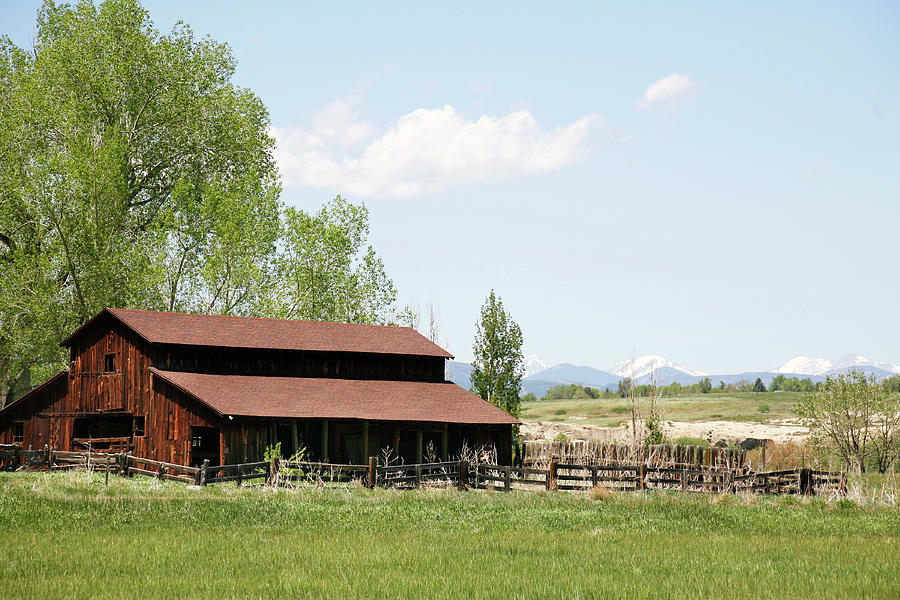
[273,92,603,198]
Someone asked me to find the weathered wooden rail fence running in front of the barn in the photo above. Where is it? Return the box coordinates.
[0,445,847,495]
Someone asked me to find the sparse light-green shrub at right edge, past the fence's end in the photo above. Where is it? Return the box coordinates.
[798,370,900,472]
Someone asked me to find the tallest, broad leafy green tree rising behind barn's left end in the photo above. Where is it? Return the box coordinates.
[0,0,279,392]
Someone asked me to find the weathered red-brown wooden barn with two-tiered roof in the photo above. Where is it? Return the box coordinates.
[0,308,519,465]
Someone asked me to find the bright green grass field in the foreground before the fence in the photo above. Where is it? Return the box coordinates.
[0,473,900,599]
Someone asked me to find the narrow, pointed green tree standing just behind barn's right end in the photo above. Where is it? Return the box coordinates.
[472,290,525,417]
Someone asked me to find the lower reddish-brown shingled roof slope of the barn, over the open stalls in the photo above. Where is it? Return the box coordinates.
[150,368,519,425]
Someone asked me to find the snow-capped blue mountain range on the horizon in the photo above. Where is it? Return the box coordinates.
[448,354,900,396]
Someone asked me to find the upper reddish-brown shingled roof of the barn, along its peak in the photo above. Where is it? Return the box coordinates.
[62,308,453,358]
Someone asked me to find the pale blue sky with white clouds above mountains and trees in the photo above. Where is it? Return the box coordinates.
[0,0,900,373]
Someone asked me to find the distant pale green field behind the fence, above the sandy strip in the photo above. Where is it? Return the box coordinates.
[521,392,801,427]
